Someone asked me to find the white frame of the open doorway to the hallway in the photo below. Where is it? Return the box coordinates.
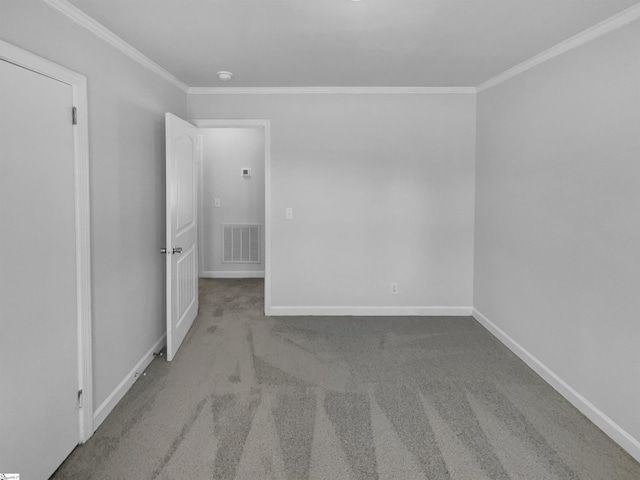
[188,119,271,316]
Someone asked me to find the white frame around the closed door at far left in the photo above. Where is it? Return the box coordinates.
[0,40,93,443]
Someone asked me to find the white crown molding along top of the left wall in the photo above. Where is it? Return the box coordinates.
[43,0,189,93]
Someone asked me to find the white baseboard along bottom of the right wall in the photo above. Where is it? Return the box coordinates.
[473,308,640,462]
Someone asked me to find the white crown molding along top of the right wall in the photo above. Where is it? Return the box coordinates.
[478,4,640,93]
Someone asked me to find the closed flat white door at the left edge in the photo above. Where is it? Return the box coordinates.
[0,60,80,479]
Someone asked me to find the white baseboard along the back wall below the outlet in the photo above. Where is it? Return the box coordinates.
[271,306,471,317]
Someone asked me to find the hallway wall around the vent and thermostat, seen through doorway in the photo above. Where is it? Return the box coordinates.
[200,127,265,276]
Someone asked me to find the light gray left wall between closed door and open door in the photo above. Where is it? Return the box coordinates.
[0,0,186,416]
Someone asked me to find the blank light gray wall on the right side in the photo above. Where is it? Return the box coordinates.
[474,17,640,458]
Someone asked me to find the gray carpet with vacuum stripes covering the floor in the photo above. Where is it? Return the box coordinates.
[53,279,640,480]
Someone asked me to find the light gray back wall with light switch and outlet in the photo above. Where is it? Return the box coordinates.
[188,94,475,313]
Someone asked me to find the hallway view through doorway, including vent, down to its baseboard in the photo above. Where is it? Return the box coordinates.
[198,127,264,278]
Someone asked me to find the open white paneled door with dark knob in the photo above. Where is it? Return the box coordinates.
[162,113,198,360]
